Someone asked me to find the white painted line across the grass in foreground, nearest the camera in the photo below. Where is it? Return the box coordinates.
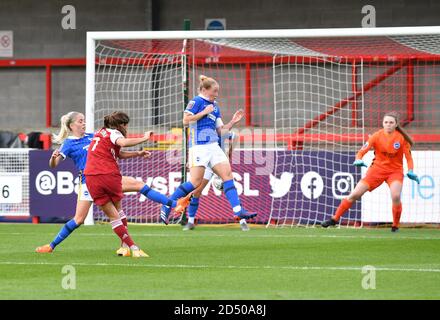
[0,261,440,273]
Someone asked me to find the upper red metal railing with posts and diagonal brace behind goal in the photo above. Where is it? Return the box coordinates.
[0,55,439,134]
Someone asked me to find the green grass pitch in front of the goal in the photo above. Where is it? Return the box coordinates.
[0,224,440,300]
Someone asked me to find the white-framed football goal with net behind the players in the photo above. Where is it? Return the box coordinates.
[86,27,440,226]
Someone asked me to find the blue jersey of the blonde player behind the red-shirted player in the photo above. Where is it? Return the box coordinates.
[60,133,94,183]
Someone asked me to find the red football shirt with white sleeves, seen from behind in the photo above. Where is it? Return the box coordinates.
[84,128,124,176]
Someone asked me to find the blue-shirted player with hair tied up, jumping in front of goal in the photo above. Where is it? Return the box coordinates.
[160,75,257,224]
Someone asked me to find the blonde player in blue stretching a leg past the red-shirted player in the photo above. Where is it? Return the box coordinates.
[36,111,189,256]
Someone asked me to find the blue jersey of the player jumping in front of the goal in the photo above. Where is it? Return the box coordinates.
[185,96,221,147]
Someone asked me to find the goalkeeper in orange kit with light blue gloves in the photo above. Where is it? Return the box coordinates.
[321,112,420,232]
